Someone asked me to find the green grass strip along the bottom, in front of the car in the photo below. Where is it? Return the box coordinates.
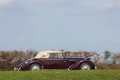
[0,70,120,80]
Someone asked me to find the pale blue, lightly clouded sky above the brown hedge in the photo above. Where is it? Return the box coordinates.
[0,0,120,52]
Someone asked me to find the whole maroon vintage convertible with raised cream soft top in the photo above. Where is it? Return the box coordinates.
[14,50,95,71]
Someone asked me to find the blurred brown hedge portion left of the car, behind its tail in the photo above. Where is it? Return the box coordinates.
[0,50,38,70]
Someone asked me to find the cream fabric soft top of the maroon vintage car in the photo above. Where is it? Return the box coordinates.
[35,50,62,58]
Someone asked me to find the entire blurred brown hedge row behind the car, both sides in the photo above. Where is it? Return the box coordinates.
[0,50,120,70]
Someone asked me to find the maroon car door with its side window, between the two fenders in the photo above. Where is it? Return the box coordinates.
[45,53,70,69]
